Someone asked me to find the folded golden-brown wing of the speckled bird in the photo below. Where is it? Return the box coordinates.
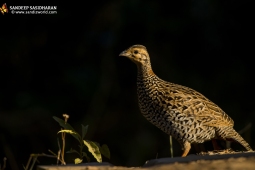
[160,82,234,127]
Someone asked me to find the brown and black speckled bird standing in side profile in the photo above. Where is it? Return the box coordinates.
[120,45,252,157]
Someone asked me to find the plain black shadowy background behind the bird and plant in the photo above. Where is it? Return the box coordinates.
[0,0,255,169]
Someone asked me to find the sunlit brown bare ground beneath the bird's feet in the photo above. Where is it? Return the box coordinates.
[37,150,255,170]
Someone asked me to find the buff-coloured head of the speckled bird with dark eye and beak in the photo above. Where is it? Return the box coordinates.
[119,45,150,66]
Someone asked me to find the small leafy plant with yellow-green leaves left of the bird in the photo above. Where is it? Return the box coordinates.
[53,114,110,164]
